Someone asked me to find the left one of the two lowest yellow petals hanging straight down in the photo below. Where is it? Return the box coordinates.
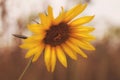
[44,45,51,71]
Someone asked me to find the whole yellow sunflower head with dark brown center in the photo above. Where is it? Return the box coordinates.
[20,4,95,72]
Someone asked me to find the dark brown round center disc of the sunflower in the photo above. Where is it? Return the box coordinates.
[44,23,69,46]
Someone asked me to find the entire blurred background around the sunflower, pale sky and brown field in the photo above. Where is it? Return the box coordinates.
[0,0,120,80]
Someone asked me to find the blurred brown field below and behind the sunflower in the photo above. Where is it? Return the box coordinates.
[0,28,120,80]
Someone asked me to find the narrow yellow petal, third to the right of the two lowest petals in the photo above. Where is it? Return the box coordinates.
[66,41,87,58]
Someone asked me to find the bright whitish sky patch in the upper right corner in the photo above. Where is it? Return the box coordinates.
[88,0,120,36]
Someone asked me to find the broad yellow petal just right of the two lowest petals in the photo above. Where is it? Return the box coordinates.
[56,46,67,67]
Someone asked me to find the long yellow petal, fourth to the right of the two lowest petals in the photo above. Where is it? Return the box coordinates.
[70,38,95,50]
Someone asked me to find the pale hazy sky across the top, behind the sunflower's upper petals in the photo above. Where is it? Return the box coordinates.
[0,0,120,44]
